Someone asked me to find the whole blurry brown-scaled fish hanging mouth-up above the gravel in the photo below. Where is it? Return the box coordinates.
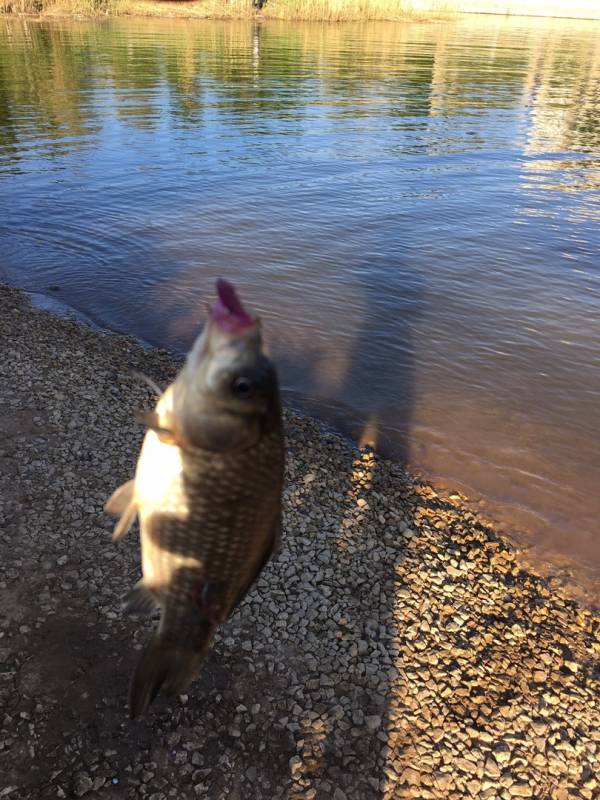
[105,279,285,718]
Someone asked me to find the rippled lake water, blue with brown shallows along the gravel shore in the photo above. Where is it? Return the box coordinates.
[0,16,600,592]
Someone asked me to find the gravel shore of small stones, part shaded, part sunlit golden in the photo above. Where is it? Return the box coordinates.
[0,286,600,800]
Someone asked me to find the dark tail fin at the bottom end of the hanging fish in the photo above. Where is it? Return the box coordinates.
[129,622,216,719]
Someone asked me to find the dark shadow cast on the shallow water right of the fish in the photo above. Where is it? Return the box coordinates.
[278,261,425,464]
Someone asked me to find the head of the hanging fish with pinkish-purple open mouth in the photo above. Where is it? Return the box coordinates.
[178,280,281,450]
